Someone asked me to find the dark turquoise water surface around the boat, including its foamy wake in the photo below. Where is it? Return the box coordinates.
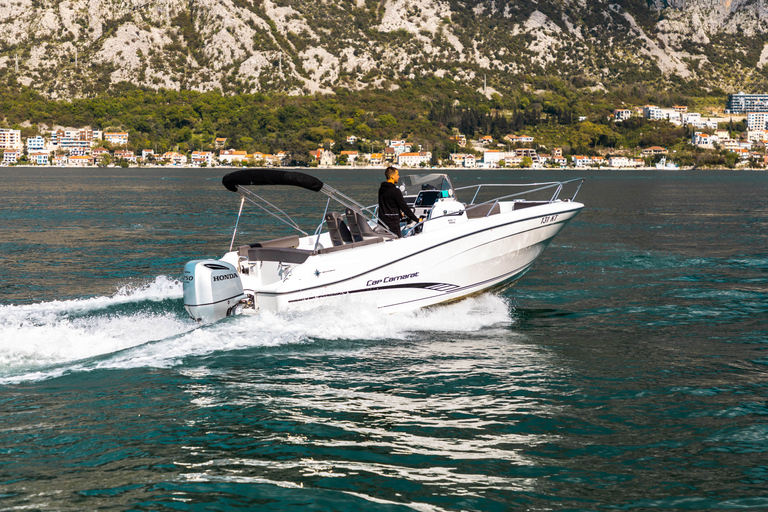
[0,168,768,512]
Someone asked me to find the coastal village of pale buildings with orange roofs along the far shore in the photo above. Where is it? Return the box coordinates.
[0,93,768,169]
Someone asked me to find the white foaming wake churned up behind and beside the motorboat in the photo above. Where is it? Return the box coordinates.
[0,276,512,384]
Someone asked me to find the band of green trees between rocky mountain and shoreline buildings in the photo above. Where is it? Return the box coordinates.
[0,77,725,165]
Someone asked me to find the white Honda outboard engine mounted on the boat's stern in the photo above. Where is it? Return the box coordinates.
[183,260,247,323]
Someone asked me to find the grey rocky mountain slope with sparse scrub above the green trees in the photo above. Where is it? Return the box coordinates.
[0,0,768,98]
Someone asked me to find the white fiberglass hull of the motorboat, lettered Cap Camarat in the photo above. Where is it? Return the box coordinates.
[228,202,583,312]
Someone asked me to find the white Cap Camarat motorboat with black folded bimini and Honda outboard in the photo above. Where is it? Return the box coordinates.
[183,169,584,322]
